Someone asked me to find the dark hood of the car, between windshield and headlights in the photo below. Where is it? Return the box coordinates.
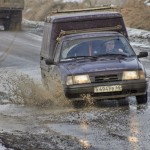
[60,57,139,74]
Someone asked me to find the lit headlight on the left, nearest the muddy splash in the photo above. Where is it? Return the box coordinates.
[66,75,91,85]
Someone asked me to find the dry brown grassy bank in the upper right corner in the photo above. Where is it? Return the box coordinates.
[121,0,150,31]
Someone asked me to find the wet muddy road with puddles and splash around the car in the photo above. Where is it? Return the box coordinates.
[0,31,150,150]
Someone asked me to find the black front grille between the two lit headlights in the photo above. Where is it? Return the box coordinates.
[95,75,119,83]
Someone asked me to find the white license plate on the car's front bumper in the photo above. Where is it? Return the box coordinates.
[94,85,122,93]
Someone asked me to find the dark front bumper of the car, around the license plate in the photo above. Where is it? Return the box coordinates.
[64,80,148,100]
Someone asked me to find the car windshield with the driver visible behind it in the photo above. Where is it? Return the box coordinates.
[60,36,135,61]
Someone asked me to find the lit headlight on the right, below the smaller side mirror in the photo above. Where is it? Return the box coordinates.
[122,70,145,80]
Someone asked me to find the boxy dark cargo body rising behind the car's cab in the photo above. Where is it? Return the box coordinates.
[41,12,128,58]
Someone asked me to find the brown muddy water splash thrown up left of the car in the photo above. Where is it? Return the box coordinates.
[0,71,70,107]
